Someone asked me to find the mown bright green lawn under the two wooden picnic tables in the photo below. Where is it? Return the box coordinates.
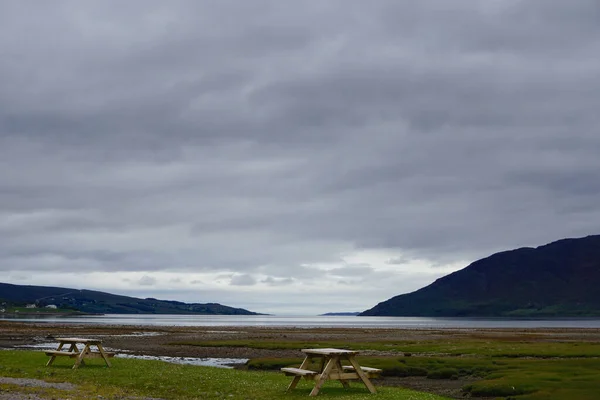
[0,351,450,400]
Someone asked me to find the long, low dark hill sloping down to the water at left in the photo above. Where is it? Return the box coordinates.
[0,283,258,315]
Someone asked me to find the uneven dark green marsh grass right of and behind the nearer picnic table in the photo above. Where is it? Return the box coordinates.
[236,339,600,400]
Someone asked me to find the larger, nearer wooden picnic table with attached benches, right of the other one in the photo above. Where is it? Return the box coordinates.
[281,348,381,396]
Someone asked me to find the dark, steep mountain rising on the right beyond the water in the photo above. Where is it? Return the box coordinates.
[360,235,600,317]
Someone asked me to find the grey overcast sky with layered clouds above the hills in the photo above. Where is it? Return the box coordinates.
[0,0,600,315]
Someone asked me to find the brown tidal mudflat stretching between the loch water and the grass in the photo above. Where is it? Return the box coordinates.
[0,321,600,358]
